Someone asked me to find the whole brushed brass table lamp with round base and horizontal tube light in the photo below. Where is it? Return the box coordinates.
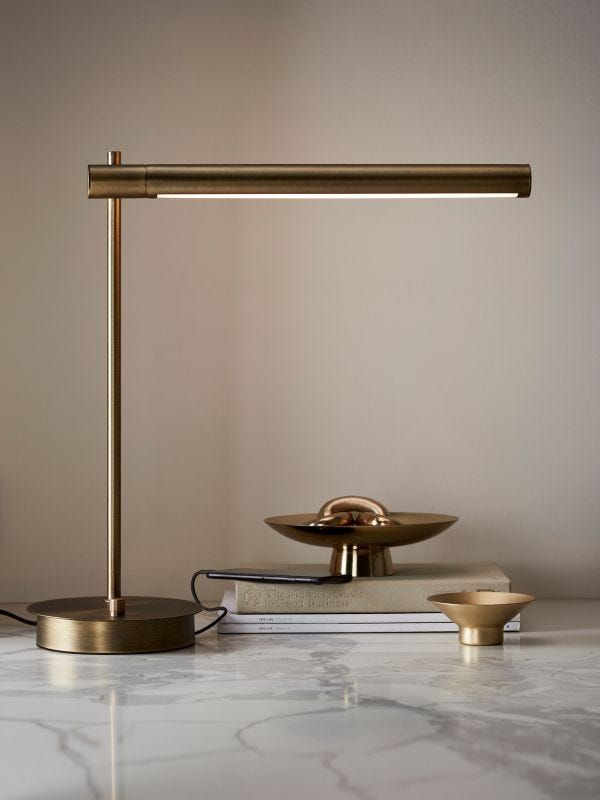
[29,150,531,653]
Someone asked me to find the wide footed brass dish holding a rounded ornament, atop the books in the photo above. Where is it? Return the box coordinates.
[265,496,458,577]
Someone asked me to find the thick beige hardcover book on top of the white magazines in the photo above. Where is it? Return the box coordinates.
[232,562,510,614]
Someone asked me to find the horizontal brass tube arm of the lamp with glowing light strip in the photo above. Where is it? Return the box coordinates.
[88,164,531,199]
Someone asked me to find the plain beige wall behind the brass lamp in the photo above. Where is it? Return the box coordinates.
[0,0,600,600]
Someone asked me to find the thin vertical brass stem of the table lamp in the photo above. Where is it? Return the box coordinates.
[106,150,125,617]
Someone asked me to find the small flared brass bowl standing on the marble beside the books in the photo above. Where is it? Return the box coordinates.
[427,592,535,645]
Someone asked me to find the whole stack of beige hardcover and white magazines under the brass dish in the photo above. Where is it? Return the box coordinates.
[218,563,520,633]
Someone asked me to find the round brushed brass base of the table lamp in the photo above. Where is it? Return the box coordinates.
[28,597,202,654]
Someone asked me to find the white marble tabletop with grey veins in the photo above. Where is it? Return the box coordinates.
[0,601,600,800]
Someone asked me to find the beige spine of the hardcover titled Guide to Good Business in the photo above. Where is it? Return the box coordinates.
[235,577,510,614]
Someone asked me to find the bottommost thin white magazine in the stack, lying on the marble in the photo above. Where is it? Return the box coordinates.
[217,622,520,634]
